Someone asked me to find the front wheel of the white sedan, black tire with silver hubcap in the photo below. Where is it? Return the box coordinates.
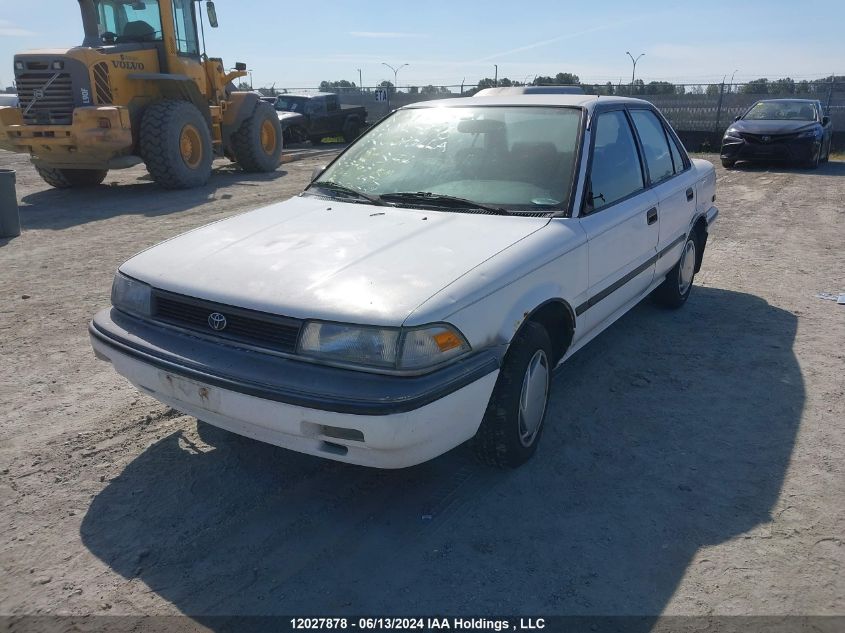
[470,321,553,468]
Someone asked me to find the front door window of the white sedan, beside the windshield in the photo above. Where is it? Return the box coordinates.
[587,110,643,211]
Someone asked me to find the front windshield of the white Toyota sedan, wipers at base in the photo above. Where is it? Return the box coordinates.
[316,106,581,212]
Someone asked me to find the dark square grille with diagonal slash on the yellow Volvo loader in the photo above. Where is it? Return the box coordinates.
[15,71,74,125]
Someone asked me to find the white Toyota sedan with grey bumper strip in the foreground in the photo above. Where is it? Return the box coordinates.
[90,94,718,468]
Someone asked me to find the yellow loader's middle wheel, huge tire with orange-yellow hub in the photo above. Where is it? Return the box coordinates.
[140,100,214,189]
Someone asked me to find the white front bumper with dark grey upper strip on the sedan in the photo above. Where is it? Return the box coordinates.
[89,309,498,468]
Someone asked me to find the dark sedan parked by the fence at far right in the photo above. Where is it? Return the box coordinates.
[721,99,833,168]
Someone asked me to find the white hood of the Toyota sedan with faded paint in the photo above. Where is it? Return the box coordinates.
[120,196,548,325]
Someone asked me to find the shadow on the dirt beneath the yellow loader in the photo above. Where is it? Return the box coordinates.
[20,165,288,230]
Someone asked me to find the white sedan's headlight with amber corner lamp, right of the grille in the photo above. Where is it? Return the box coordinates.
[299,321,470,370]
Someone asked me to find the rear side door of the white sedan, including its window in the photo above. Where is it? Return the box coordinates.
[629,107,696,277]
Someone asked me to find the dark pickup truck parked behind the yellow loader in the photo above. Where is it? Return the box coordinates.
[275,92,367,144]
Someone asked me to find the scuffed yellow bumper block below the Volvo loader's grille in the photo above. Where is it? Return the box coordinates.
[0,106,137,169]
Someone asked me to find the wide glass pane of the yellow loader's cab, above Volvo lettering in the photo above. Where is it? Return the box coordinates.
[80,0,162,45]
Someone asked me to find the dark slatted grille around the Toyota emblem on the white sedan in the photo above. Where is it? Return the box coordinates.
[153,290,302,354]
